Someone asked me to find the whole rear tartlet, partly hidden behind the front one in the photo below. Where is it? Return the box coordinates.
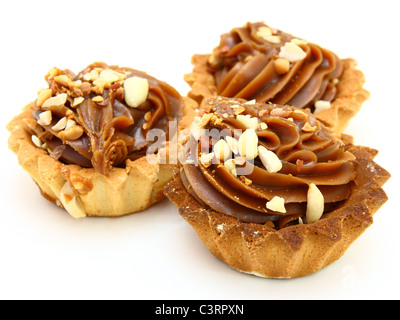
[185,22,369,132]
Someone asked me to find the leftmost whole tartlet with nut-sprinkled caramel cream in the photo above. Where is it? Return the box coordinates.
[7,62,197,218]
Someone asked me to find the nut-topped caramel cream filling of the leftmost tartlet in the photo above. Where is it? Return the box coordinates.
[28,63,183,174]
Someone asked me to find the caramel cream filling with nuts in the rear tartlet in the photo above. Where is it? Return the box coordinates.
[209,22,342,111]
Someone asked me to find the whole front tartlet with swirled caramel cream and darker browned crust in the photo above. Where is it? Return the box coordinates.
[165,97,390,278]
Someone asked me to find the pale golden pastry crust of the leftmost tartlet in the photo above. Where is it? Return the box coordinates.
[7,98,197,217]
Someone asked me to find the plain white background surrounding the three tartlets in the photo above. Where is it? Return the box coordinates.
[0,0,400,300]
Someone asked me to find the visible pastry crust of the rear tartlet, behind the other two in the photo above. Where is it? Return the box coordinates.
[184,54,369,133]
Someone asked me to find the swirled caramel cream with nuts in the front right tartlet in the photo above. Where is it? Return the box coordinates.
[181,97,355,228]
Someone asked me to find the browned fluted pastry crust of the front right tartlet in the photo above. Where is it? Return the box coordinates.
[165,137,390,278]
